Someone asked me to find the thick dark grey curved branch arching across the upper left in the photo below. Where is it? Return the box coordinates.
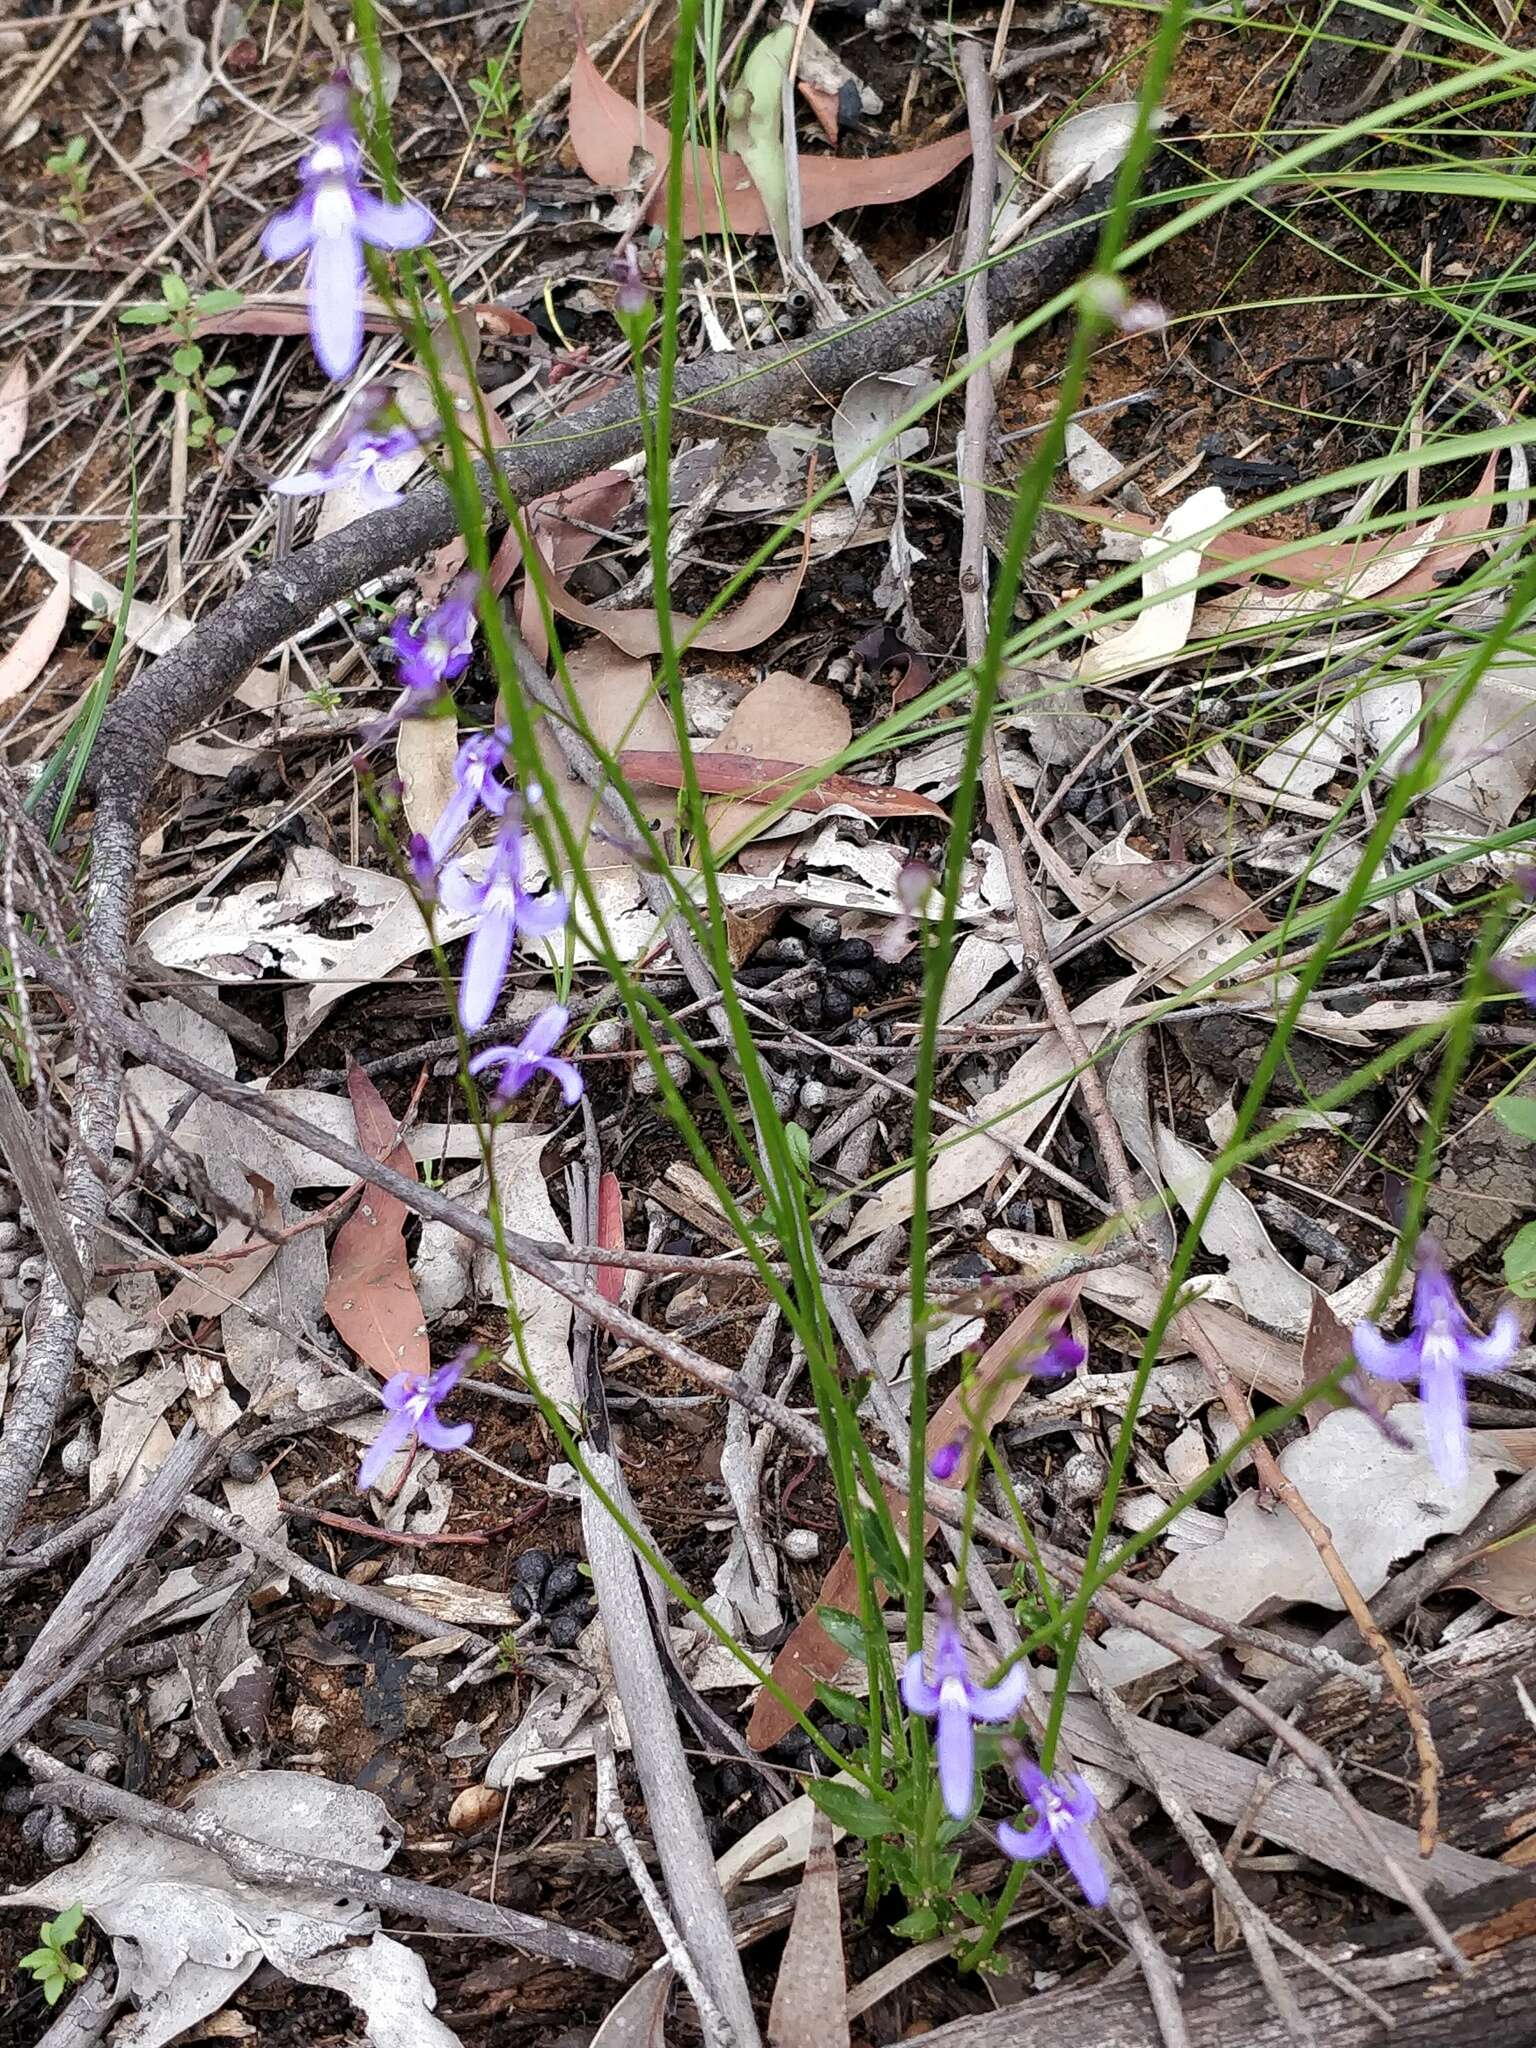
[0,164,1176,1546]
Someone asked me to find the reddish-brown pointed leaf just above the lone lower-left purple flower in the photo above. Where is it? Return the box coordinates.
[324,1067,432,1380]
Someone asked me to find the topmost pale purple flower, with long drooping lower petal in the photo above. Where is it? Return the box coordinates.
[262,78,432,383]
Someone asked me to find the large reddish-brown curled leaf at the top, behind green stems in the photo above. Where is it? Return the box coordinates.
[571,43,971,236]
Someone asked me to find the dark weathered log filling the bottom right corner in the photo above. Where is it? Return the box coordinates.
[909,1878,1536,2048]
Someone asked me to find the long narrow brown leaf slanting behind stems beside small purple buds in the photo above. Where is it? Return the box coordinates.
[748,1274,1083,1751]
